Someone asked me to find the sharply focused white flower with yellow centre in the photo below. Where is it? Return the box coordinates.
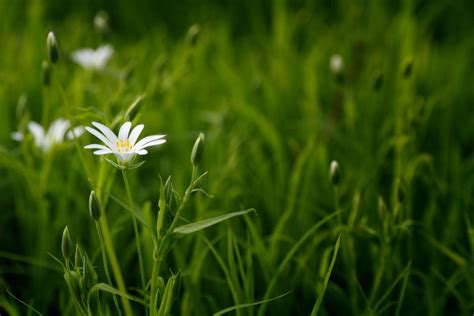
[84,122,166,166]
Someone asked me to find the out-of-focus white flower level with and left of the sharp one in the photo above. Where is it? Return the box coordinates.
[11,118,84,153]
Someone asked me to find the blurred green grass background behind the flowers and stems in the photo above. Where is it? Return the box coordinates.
[0,0,474,315]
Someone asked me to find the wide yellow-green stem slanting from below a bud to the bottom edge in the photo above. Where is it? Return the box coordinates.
[100,213,133,316]
